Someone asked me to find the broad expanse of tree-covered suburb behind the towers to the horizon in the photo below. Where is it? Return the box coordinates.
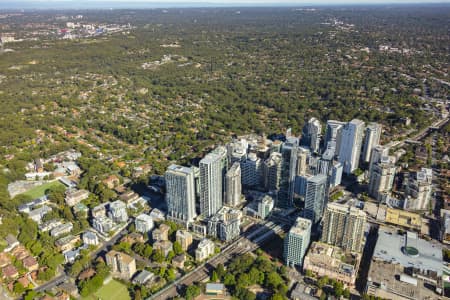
[0,7,449,176]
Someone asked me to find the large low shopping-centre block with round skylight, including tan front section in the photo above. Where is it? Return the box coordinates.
[366,227,444,300]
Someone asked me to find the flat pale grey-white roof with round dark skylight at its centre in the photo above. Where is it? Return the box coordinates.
[373,227,443,276]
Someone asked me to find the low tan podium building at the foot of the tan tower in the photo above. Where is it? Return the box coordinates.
[303,242,361,287]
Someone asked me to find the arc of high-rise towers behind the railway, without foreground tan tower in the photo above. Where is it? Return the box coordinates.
[165,118,390,237]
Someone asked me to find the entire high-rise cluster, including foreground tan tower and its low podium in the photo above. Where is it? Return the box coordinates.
[165,118,440,296]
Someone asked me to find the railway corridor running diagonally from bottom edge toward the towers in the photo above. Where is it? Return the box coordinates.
[148,221,290,299]
